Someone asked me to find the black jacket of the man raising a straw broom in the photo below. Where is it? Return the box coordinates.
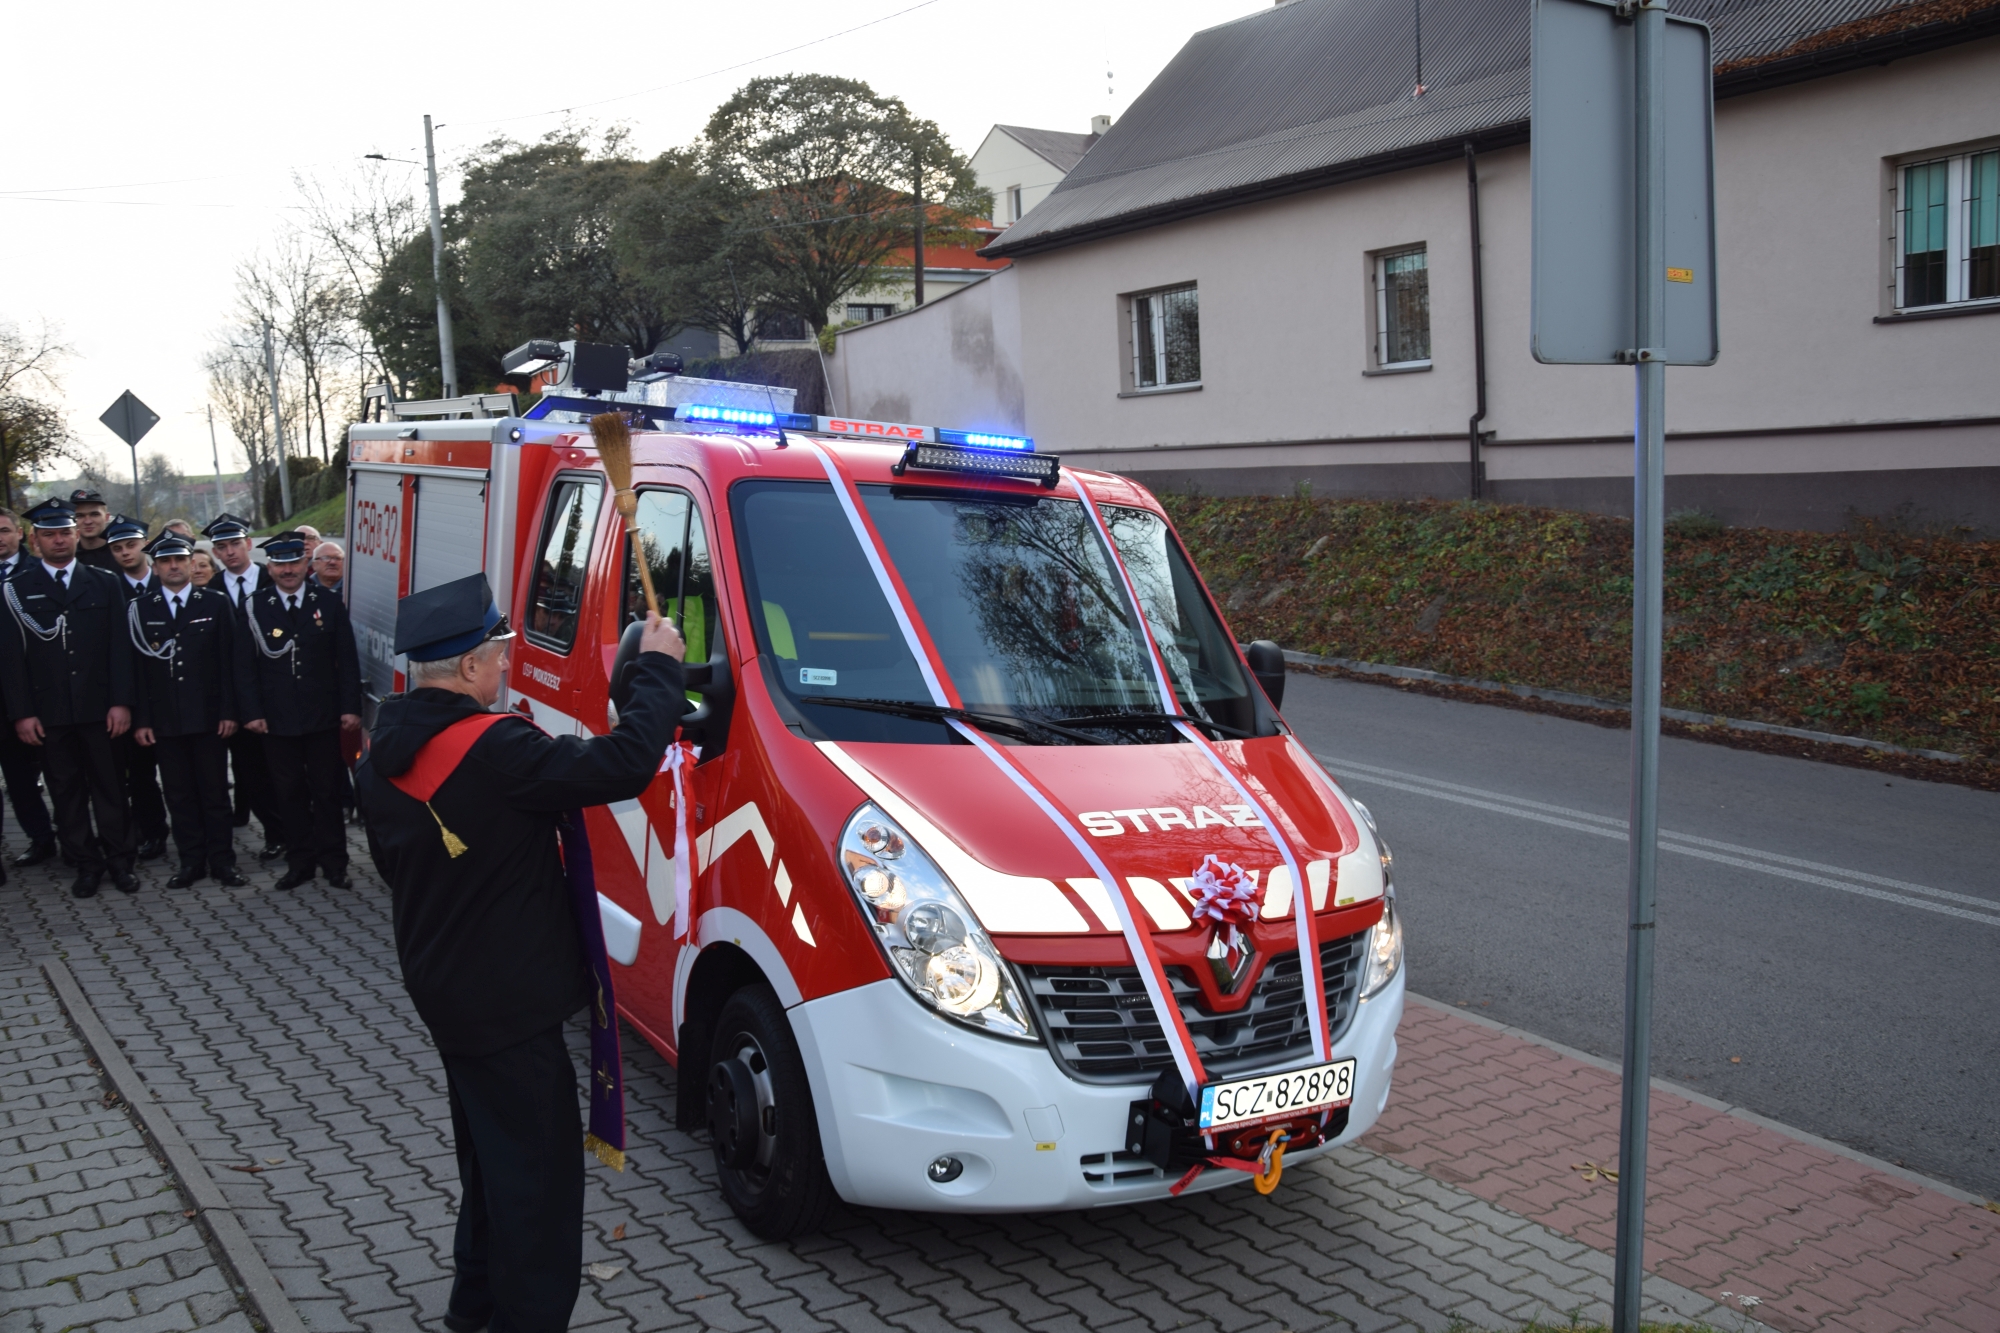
[354,652,686,1055]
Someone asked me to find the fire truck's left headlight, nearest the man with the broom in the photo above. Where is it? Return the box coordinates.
[840,803,1034,1041]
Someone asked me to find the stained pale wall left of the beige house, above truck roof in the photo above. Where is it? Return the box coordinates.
[826,268,1028,434]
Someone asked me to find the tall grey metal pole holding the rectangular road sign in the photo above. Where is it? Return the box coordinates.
[1612,0,1666,1333]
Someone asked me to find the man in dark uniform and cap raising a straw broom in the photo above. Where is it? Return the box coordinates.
[354,574,686,1333]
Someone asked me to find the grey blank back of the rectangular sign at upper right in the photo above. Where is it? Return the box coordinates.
[1528,0,1716,366]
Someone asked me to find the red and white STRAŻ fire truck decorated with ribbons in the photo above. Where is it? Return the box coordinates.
[348,348,1402,1237]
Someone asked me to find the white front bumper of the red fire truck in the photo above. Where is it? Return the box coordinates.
[790,971,1402,1213]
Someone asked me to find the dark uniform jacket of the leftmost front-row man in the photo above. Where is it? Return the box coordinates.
[0,560,132,727]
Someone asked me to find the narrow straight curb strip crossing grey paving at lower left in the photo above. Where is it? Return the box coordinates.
[38,959,308,1333]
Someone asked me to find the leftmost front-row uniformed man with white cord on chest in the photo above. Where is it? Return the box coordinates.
[0,500,138,899]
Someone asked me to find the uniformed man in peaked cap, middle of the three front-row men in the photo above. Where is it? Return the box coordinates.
[129,532,250,889]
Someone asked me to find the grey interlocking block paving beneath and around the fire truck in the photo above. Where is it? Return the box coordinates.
[0,824,1756,1333]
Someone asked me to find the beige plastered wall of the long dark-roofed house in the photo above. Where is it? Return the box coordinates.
[832,40,2000,530]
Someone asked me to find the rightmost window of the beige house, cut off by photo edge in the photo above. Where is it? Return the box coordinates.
[1896,148,2000,310]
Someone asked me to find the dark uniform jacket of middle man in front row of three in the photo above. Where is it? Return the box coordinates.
[126,584,250,737]
